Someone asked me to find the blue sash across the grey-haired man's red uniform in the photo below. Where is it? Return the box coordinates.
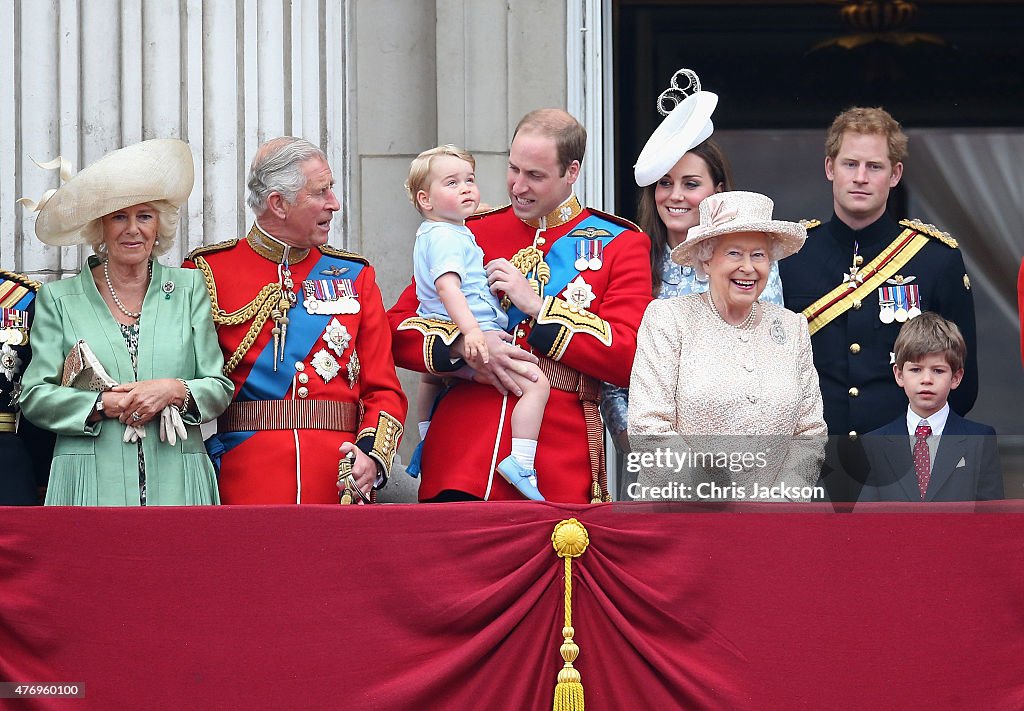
[207,254,364,458]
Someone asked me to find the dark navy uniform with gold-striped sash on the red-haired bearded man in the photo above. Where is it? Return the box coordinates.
[779,214,978,500]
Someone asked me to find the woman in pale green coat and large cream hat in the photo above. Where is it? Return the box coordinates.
[22,139,233,506]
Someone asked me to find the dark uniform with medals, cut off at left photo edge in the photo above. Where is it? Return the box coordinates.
[0,269,54,506]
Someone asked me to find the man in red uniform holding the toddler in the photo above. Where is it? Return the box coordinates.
[388,109,650,503]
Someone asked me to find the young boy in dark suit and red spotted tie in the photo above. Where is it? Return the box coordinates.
[859,311,1002,501]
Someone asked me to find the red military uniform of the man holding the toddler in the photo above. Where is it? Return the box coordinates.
[388,196,651,503]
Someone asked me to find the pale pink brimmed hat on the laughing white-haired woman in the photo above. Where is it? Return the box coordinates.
[672,191,807,266]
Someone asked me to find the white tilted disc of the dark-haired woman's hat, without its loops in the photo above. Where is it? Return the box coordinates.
[633,91,718,187]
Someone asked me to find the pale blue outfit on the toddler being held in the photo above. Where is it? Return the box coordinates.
[413,220,509,331]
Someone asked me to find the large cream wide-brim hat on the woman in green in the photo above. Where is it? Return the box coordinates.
[36,138,196,247]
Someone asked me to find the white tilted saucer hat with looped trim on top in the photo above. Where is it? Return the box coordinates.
[633,69,718,187]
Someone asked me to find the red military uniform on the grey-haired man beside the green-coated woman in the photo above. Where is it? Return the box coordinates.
[185,224,407,504]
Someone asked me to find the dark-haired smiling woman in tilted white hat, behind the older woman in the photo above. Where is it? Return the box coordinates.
[601,69,782,465]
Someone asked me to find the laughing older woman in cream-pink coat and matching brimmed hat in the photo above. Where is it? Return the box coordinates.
[629,192,826,500]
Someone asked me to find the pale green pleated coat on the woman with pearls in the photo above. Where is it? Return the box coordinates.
[22,258,233,506]
